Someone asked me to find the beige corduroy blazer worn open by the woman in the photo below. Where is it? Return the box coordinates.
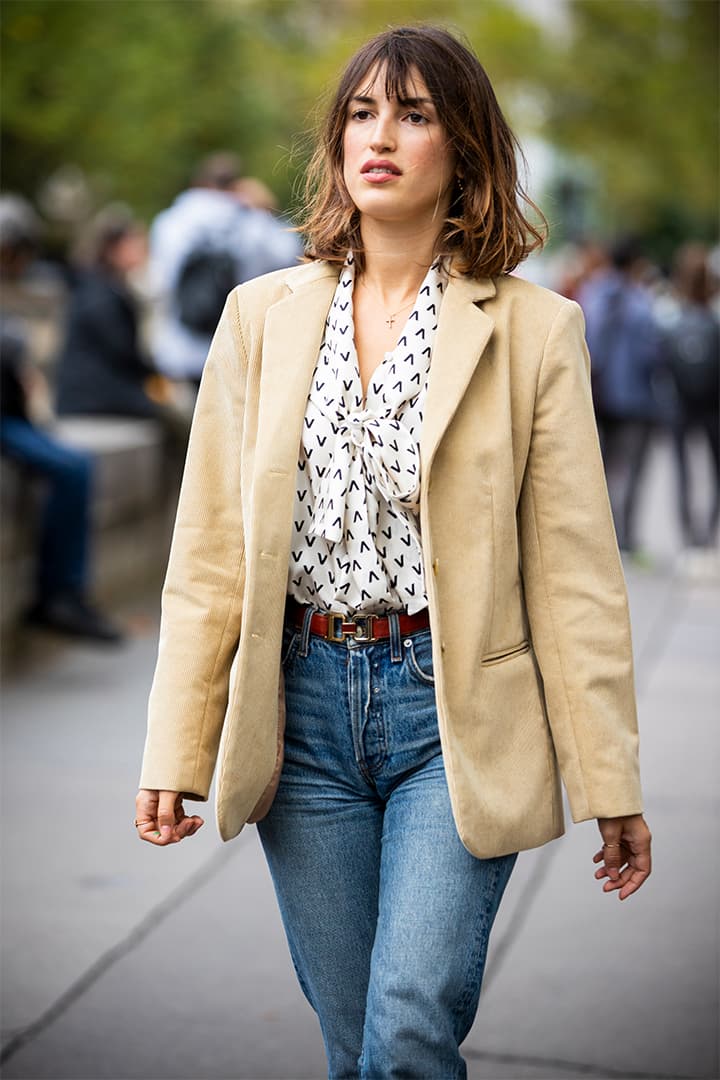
[140,262,642,858]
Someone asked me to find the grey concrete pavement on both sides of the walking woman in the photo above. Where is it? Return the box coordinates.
[2,440,720,1080]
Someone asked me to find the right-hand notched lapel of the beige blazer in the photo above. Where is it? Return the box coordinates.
[420,276,495,483]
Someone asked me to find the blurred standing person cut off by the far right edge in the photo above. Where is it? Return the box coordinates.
[663,244,720,548]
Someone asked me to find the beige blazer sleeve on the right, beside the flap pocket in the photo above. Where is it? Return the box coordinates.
[519,301,642,821]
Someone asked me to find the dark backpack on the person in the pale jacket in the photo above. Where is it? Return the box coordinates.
[174,244,240,337]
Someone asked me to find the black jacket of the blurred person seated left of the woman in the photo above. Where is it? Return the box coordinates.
[56,271,157,417]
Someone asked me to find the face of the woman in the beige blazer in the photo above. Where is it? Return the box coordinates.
[343,68,456,229]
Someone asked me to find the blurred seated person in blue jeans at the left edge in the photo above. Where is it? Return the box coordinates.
[0,195,122,643]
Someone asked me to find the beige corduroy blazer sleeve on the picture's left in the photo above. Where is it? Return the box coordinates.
[140,293,247,799]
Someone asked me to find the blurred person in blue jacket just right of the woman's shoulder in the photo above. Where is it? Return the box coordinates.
[578,238,667,552]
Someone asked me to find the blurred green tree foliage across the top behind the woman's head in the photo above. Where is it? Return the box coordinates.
[1,0,719,244]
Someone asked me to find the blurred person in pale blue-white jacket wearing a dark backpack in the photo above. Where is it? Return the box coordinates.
[150,152,301,384]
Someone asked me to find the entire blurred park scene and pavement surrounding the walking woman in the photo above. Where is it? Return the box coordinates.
[0,0,720,1080]
